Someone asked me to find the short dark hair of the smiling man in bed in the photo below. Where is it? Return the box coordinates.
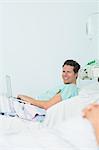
[62,59,80,73]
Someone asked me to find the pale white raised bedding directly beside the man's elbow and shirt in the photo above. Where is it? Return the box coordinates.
[44,92,99,127]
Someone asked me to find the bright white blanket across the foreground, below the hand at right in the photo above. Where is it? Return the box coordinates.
[0,116,97,150]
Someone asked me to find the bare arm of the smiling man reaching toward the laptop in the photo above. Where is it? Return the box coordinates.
[17,93,62,110]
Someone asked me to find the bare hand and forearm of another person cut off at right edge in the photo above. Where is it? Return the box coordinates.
[83,104,99,144]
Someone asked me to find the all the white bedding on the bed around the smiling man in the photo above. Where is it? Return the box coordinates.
[0,82,99,150]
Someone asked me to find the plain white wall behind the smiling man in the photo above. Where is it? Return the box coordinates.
[0,1,98,96]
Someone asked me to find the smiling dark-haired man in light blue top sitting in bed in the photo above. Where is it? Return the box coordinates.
[17,60,80,110]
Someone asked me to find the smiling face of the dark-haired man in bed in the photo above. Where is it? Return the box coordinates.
[62,65,78,84]
